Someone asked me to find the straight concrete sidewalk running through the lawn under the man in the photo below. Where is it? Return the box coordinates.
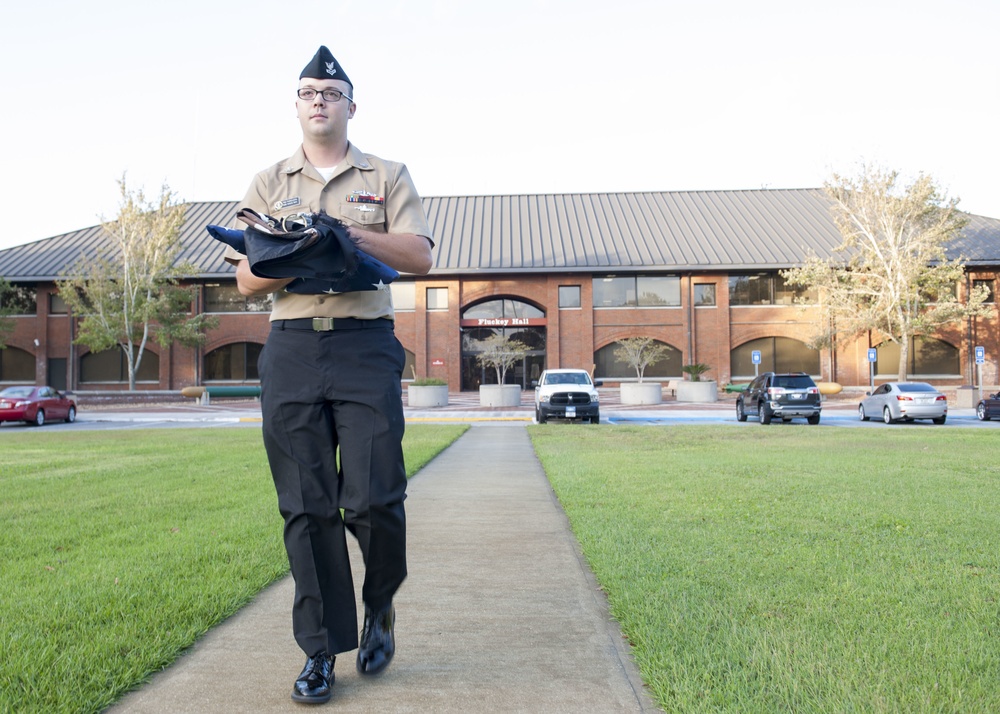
[108,424,656,714]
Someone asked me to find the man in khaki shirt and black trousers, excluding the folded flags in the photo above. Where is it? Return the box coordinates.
[226,47,433,703]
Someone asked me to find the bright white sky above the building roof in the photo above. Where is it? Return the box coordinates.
[0,0,1000,248]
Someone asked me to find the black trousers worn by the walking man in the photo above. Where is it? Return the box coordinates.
[258,320,406,657]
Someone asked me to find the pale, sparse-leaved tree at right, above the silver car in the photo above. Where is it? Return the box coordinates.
[782,166,987,382]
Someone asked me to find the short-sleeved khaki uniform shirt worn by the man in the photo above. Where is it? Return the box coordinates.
[224,144,433,320]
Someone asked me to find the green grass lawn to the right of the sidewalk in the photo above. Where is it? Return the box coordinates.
[529,425,1000,713]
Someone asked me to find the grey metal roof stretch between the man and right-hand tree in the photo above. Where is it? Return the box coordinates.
[424,189,841,273]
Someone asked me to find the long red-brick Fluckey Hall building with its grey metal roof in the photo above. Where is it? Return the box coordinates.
[0,189,1000,390]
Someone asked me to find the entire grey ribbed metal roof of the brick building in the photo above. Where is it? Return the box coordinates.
[0,189,1000,282]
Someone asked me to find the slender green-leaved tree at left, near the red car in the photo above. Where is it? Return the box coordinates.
[56,176,215,390]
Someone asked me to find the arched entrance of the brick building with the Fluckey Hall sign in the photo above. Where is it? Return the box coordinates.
[460,298,546,391]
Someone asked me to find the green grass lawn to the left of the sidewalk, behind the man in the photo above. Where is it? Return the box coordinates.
[0,425,466,714]
